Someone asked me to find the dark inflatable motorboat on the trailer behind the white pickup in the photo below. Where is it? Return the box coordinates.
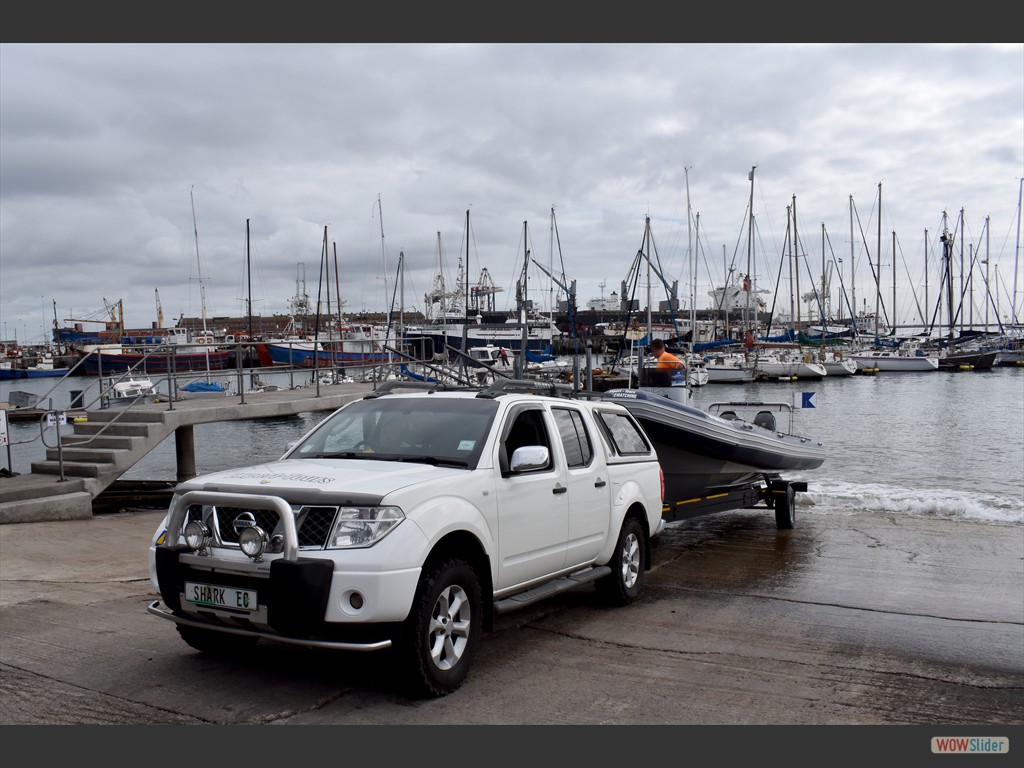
[602,389,825,502]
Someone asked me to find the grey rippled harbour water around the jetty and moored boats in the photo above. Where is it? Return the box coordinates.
[0,368,1024,525]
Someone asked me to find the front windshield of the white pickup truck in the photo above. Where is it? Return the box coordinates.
[285,396,498,469]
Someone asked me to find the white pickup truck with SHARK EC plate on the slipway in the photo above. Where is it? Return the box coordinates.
[148,381,664,696]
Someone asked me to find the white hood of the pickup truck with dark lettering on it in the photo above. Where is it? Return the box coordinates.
[176,459,466,504]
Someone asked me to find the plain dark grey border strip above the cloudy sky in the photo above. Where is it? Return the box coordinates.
[0,0,1020,44]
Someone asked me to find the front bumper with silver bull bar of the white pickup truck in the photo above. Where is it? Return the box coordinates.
[148,492,427,650]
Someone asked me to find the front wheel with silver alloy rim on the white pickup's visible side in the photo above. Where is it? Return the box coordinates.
[398,558,483,697]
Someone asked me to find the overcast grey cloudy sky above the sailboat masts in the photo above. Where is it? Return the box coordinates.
[0,43,1024,342]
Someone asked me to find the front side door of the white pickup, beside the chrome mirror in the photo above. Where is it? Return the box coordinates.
[495,406,569,590]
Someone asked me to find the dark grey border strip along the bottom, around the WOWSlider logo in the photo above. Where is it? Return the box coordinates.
[6,724,1024,768]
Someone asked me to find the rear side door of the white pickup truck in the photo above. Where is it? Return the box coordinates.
[551,407,611,565]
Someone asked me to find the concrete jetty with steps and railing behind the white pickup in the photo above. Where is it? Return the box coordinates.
[0,382,374,524]
